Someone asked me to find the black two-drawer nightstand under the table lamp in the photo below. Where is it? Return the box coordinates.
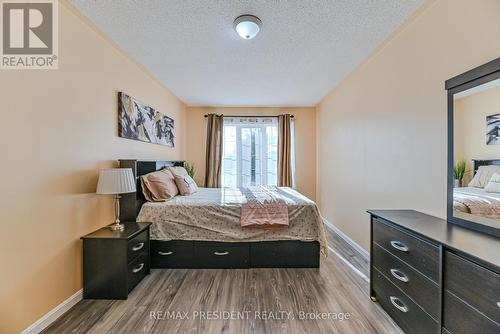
[81,222,151,299]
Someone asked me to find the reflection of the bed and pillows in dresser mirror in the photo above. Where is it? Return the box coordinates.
[453,159,500,219]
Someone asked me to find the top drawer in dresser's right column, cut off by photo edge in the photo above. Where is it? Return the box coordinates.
[444,252,500,323]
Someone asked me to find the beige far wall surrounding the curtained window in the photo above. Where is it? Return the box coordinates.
[186,107,316,199]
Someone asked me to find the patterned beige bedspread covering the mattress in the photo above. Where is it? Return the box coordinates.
[137,187,328,255]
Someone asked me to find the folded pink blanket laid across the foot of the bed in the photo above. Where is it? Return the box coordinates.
[240,186,288,228]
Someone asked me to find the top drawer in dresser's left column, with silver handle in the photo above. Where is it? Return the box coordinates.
[372,218,439,282]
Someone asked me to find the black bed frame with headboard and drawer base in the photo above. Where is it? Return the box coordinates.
[120,160,320,268]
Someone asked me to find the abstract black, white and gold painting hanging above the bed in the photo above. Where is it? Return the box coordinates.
[118,92,174,147]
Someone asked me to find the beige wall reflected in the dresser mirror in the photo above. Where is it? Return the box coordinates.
[454,87,500,185]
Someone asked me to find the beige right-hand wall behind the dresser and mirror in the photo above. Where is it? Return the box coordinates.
[316,0,500,249]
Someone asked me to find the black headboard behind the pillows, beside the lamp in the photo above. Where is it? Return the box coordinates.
[119,159,184,222]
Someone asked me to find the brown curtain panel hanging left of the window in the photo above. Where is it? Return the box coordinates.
[205,114,224,188]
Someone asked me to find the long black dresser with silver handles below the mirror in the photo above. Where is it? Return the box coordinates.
[368,210,500,334]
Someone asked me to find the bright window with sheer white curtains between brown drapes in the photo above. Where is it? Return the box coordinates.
[221,117,295,187]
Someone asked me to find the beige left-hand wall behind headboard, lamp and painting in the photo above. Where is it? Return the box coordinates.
[0,5,185,334]
